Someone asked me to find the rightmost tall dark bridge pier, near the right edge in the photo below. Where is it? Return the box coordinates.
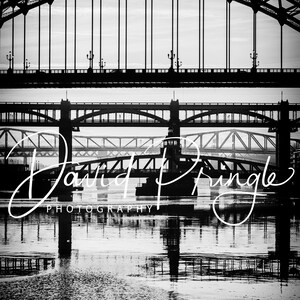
[276,101,291,185]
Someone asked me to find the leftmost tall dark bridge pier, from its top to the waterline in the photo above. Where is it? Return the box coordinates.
[58,100,72,201]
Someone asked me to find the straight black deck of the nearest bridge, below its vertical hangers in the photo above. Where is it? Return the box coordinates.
[0,69,300,88]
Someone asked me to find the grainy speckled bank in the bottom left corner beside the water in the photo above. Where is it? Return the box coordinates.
[0,268,172,300]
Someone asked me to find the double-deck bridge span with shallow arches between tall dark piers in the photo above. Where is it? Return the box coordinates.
[0,101,300,131]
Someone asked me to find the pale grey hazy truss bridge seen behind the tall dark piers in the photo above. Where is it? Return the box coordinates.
[0,128,300,158]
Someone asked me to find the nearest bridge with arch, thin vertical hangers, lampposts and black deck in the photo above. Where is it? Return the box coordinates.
[0,0,300,88]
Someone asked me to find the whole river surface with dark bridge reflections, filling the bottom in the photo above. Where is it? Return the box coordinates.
[0,179,300,300]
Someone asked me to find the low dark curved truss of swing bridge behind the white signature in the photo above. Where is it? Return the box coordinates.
[46,154,278,179]
